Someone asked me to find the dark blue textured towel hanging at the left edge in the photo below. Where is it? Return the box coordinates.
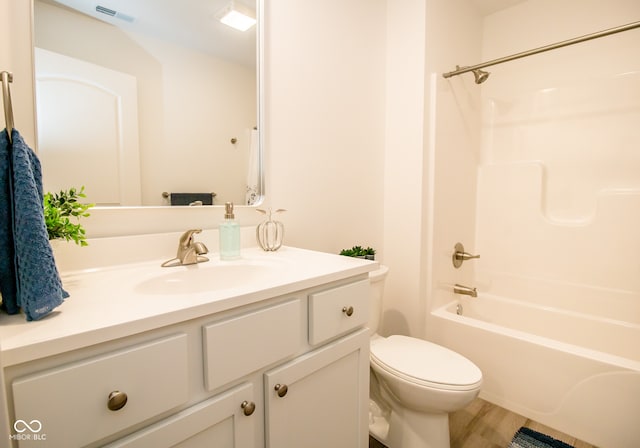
[0,129,69,321]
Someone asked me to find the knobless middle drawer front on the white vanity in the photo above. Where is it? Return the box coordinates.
[204,299,303,390]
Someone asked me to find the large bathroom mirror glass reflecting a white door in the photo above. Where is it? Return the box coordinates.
[33,0,264,207]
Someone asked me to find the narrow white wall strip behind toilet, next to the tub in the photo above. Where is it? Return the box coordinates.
[379,0,426,335]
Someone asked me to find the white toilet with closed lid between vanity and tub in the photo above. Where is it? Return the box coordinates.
[369,266,482,448]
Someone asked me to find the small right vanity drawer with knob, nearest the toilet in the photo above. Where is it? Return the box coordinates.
[309,279,371,345]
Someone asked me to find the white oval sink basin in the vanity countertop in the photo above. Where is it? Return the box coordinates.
[135,259,283,295]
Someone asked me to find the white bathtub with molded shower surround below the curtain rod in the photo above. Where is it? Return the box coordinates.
[427,2,640,448]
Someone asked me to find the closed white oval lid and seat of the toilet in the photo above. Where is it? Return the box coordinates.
[371,335,482,389]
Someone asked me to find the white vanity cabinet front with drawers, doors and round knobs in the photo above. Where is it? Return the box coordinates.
[4,262,369,448]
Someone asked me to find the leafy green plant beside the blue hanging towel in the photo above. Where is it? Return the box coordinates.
[44,186,95,246]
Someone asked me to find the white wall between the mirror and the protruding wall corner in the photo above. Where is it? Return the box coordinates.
[265,0,385,259]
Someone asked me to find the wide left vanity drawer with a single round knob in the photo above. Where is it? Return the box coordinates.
[12,334,189,448]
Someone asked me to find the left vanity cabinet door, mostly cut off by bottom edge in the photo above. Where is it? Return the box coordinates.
[106,383,255,448]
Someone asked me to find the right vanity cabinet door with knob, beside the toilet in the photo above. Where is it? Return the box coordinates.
[265,329,369,448]
